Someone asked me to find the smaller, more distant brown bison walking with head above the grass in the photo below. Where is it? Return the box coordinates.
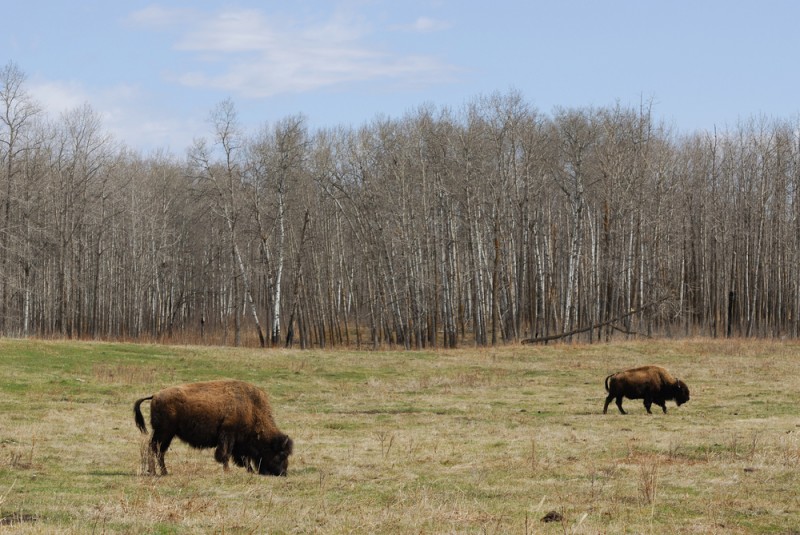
[603,366,689,414]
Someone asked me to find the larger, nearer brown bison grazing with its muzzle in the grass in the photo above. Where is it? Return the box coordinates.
[133,380,293,476]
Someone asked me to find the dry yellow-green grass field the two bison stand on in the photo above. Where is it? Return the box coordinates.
[0,339,800,534]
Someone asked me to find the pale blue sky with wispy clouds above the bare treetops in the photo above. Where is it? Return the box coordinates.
[6,0,800,155]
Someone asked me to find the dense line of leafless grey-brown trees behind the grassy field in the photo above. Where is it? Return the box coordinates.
[0,63,800,349]
